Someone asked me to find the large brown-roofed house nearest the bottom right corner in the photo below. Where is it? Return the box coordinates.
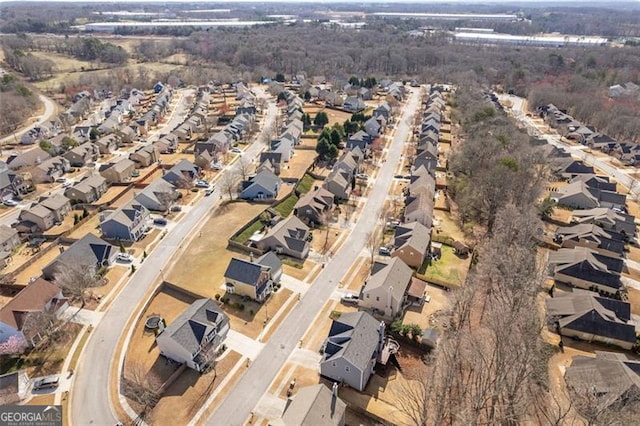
[564,351,640,412]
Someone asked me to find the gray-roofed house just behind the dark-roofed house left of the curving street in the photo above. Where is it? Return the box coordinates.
[100,200,150,241]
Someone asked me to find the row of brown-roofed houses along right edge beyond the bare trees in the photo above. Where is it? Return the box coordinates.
[543,141,640,409]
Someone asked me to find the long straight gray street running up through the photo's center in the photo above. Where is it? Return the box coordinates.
[202,90,420,426]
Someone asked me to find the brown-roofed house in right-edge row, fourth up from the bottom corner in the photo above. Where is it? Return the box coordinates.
[554,223,625,257]
